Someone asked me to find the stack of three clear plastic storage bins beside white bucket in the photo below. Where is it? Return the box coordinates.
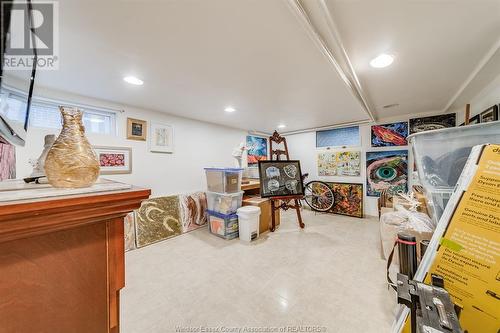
[205,168,243,239]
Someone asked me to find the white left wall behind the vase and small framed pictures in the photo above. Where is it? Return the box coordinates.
[16,84,247,196]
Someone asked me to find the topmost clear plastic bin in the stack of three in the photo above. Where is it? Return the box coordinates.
[205,168,243,193]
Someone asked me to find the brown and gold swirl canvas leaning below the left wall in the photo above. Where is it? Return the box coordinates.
[135,195,182,247]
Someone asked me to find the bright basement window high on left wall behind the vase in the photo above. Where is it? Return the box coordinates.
[0,89,116,135]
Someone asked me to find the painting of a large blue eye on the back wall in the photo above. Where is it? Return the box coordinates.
[366,150,408,197]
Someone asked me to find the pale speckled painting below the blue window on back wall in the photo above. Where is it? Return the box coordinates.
[317,150,361,177]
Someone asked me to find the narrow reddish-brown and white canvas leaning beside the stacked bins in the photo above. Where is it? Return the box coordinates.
[179,192,207,233]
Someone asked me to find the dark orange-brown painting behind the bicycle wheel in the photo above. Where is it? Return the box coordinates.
[326,182,363,217]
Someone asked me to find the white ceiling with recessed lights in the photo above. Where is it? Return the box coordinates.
[35,0,500,132]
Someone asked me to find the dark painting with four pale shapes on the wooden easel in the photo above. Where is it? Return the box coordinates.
[259,161,304,198]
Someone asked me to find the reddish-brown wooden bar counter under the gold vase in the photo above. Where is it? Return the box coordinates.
[0,181,150,333]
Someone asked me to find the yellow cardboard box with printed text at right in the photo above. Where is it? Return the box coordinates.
[425,145,500,333]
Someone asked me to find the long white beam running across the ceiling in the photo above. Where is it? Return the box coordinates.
[287,0,376,121]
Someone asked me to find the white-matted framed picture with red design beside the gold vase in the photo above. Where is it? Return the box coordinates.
[93,146,132,175]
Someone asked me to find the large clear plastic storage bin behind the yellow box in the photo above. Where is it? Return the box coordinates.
[408,121,500,222]
